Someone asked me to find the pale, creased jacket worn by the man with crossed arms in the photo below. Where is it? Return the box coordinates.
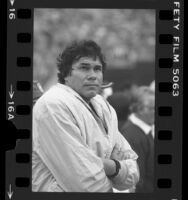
[32,83,139,192]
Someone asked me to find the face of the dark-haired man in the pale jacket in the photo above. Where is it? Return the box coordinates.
[65,57,103,101]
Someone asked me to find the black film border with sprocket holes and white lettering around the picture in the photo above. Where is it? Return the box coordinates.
[5,0,184,200]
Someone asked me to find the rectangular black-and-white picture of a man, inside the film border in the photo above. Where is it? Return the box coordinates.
[31,8,156,193]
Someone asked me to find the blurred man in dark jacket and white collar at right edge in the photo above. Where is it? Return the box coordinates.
[121,86,155,193]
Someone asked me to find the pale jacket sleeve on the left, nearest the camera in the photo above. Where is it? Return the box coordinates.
[33,101,112,192]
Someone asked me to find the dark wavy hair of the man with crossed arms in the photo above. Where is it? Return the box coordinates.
[57,40,106,83]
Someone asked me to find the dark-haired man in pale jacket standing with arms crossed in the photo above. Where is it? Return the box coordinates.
[32,41,139,192]
